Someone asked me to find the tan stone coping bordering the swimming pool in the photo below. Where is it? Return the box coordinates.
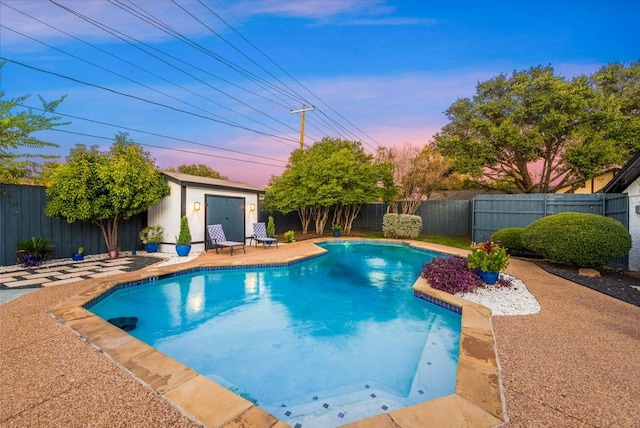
[49,238,507,427]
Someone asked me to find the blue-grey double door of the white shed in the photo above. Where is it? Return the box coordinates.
[205,195,245,242]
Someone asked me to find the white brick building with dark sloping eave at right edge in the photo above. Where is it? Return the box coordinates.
[602,151,640,271]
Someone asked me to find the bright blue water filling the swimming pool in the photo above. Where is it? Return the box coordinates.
[90,241,460,427]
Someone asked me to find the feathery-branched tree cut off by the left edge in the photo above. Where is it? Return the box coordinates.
[0,83,67,183]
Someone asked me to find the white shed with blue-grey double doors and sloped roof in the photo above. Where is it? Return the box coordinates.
[147,172,264,252]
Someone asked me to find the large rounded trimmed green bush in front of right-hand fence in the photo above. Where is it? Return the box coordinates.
[522,212,631,268]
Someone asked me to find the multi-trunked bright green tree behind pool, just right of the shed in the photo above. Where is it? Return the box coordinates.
[265,138,388,234]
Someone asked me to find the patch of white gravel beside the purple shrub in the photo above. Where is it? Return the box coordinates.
[456,274,540,316]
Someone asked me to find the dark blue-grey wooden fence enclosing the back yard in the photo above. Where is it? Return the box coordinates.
[0,184,629,267]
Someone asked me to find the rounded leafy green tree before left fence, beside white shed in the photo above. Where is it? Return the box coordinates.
[45,133,169,251]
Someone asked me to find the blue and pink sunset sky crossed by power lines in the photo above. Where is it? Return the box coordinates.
[0,0,640,186]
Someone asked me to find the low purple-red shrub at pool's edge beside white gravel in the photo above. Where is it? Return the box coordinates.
[422,256,482,294]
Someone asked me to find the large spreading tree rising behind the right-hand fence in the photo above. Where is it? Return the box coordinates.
[434,66,638,193]
